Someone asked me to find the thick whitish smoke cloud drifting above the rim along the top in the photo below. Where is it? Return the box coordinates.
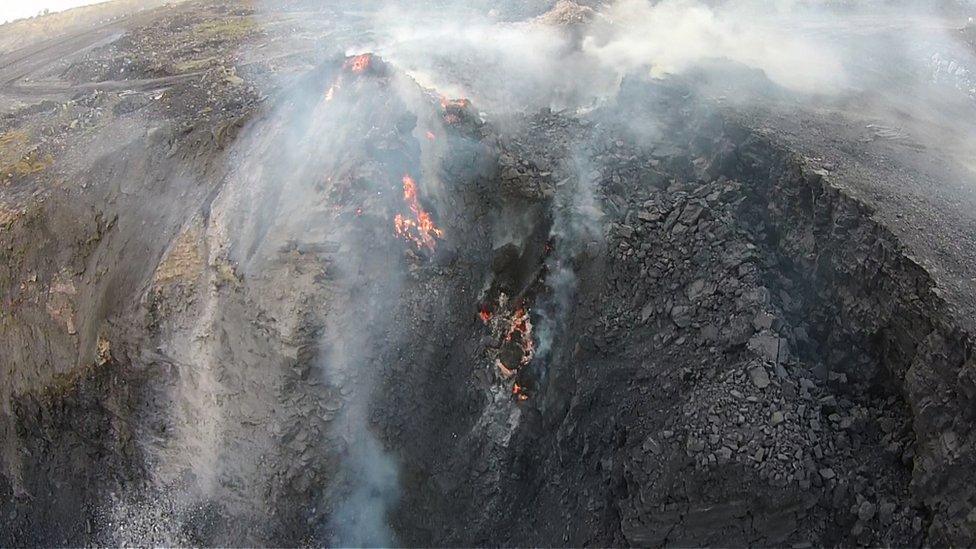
[338,0,976,133]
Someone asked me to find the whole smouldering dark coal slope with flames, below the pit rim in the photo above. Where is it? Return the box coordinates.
[0,2,976,547]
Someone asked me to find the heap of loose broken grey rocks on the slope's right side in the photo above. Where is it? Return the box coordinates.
[580,126,923,544]
